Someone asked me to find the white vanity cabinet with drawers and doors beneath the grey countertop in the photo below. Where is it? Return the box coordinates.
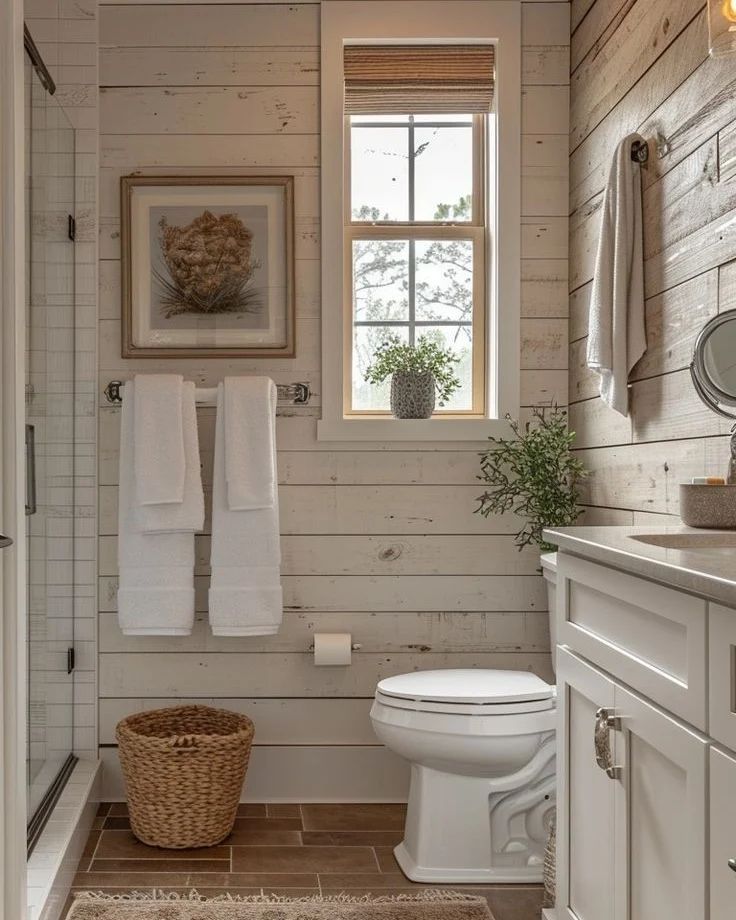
[556,554,736,920]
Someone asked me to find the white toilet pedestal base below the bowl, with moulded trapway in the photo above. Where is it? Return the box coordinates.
[394,752,555,884]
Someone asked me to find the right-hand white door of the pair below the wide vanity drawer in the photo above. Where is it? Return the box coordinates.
[615,685,712,920]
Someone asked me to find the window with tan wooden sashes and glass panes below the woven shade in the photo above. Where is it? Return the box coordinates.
[344,115,487,415]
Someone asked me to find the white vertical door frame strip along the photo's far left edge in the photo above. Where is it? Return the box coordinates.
[0,0,27,920]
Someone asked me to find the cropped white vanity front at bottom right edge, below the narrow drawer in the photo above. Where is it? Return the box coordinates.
[710,748,736,920]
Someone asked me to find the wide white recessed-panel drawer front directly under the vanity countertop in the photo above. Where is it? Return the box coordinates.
[557,553,707,730]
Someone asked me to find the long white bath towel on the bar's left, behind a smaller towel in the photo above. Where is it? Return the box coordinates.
[118,382,204,636]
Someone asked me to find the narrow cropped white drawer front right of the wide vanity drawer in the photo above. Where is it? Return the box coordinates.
[708,604,736,756]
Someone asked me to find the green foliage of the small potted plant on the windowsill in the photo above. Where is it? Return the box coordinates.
[365,335,460,406]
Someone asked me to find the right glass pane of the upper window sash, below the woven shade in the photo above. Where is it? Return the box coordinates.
[414,126,473,221]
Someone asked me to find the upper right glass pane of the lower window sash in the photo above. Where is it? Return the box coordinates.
[414,240,473,323]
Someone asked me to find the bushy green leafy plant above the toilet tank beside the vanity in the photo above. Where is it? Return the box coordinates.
[476,406,588,552]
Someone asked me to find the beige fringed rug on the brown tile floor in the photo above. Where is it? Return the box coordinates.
[68,890,493,920]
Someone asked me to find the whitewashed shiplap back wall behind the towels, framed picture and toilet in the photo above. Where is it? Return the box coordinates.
[99,0,569,800]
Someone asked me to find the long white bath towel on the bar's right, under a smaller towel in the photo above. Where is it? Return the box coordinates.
[209,381,283,636]
